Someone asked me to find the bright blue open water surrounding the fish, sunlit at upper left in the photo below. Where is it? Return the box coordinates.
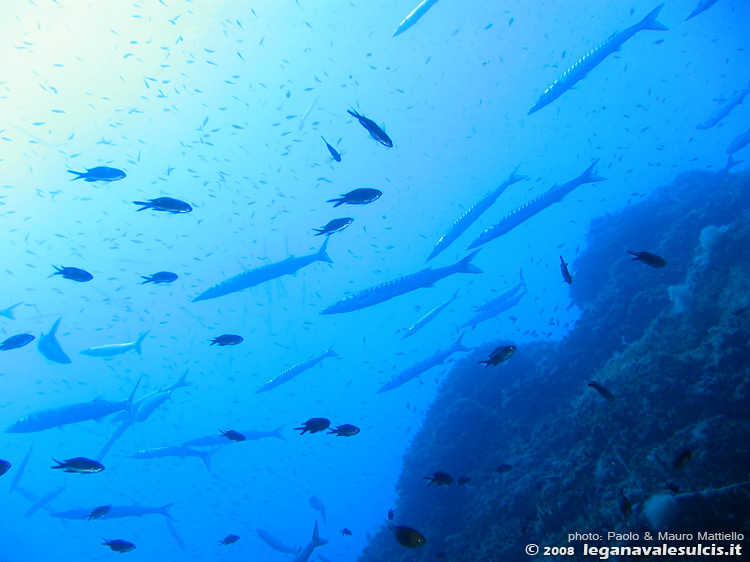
[0,0,750,562]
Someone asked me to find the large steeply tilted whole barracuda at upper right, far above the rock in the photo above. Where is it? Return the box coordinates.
[529,4,667,115]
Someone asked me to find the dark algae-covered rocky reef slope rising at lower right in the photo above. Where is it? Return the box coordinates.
[360,173,750,562]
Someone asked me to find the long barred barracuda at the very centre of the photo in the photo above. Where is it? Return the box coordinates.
[320,252,482,314]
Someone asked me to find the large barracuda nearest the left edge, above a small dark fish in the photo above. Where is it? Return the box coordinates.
[5,379,141,433]
